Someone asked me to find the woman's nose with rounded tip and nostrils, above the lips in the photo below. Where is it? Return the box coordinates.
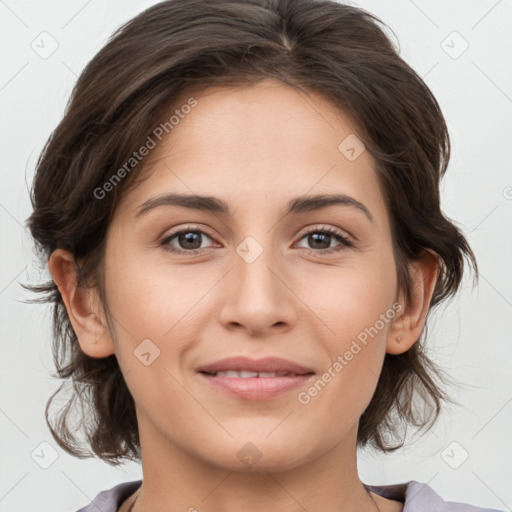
[219,242,298,336]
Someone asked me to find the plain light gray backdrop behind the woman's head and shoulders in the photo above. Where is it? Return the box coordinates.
[0,0,512,512]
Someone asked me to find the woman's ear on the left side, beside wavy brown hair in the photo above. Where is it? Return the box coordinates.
[48,249,115,358]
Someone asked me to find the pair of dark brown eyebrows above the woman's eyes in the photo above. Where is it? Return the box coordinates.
[135,193,374,222]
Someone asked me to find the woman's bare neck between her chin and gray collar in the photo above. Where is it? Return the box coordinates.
[127,416,379,512]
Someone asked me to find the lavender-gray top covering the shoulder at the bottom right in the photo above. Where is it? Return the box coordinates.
[365,480,504,512]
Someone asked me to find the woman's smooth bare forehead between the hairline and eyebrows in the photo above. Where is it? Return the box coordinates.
[116,79,385,228]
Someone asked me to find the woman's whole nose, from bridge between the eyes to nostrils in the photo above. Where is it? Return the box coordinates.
[221,233,296,334]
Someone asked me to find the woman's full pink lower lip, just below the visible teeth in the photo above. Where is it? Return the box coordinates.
[198,373,314,400]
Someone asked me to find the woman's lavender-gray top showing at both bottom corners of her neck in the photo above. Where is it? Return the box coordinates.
[77,480,505,512]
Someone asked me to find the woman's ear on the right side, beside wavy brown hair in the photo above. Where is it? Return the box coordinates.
[386,249,439,354]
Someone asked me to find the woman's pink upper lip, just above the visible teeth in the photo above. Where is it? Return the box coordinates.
[197,356,314,375]
